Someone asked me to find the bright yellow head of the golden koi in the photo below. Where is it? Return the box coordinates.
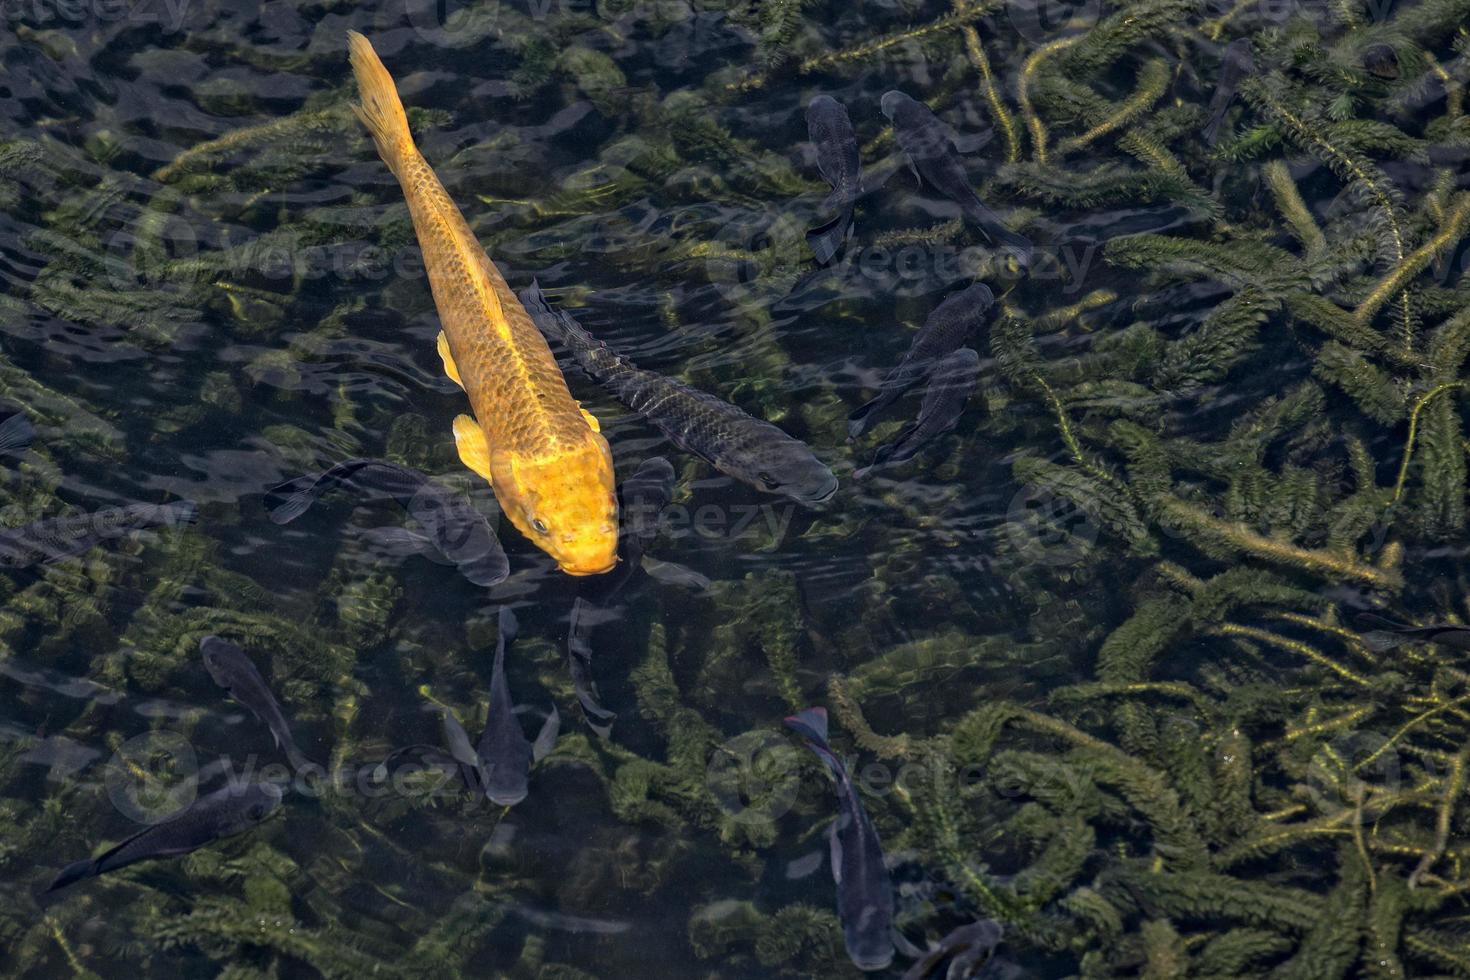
[495,430,617,574]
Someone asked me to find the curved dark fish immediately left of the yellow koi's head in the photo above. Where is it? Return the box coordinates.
[266,460,510,588]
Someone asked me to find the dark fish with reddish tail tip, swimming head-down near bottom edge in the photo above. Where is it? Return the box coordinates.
[786,708,894,970]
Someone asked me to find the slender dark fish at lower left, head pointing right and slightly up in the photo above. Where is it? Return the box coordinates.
[46,783,281,892]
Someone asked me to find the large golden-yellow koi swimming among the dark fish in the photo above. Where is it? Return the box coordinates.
[347,31,617,574]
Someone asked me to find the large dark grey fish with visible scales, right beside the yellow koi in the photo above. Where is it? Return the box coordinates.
[520,282,836,504]
